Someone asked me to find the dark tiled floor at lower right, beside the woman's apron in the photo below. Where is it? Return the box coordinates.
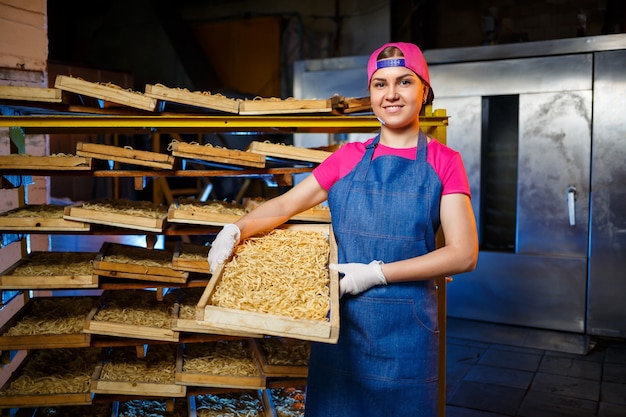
[446,319,626,417]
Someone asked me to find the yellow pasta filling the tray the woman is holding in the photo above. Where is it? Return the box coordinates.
[211,229,330,320]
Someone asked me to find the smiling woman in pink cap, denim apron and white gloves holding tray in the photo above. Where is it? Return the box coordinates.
[209,39,478,417]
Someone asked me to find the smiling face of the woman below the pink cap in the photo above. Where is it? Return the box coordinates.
[369,67,428,128]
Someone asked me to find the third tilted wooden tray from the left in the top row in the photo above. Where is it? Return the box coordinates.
[145,84,239,114]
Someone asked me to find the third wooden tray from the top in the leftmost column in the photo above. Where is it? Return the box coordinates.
[0,204,91,232]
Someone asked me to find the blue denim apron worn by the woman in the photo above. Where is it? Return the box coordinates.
[305,132,442,417]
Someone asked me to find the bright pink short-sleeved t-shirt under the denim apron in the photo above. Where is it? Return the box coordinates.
[313,138,471,197]
